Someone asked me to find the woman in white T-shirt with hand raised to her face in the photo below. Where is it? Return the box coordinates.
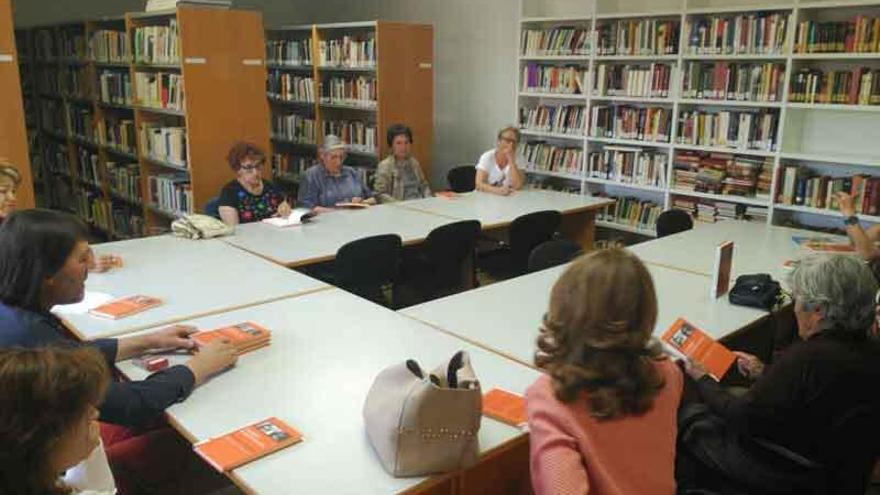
[476,126,525,196]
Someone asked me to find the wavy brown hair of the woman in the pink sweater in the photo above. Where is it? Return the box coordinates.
[535,249,663,420]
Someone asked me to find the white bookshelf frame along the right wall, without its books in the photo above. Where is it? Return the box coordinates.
[515,0,880,235]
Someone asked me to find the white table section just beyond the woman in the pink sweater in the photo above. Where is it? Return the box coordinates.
[400,265,768,366]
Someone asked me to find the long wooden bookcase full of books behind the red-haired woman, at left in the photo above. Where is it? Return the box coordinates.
[21,7,269,239]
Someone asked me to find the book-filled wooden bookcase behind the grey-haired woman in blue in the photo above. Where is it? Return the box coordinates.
[266,21,434,196]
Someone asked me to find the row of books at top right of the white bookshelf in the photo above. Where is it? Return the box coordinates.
[794,15,880,53]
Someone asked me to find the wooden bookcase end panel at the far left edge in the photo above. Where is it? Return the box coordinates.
[0,0,34,209]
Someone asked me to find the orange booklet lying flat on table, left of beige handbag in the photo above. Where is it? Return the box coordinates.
[193,417,302,473]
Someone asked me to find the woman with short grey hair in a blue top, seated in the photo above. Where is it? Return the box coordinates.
[299,134,376,212]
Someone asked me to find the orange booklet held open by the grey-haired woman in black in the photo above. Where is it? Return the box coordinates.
[660,318,736,381]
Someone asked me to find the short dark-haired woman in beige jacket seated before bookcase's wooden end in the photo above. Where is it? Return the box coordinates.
[374,124,431,203]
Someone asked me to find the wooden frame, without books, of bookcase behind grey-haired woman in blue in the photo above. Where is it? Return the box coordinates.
[266,21,434,196]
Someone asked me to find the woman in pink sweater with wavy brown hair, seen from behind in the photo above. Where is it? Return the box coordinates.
[526,249,683,495]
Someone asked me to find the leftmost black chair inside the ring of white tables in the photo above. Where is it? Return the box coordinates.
[333,234,403,309]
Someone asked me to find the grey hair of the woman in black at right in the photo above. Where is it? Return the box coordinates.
[789,254,877,334]
